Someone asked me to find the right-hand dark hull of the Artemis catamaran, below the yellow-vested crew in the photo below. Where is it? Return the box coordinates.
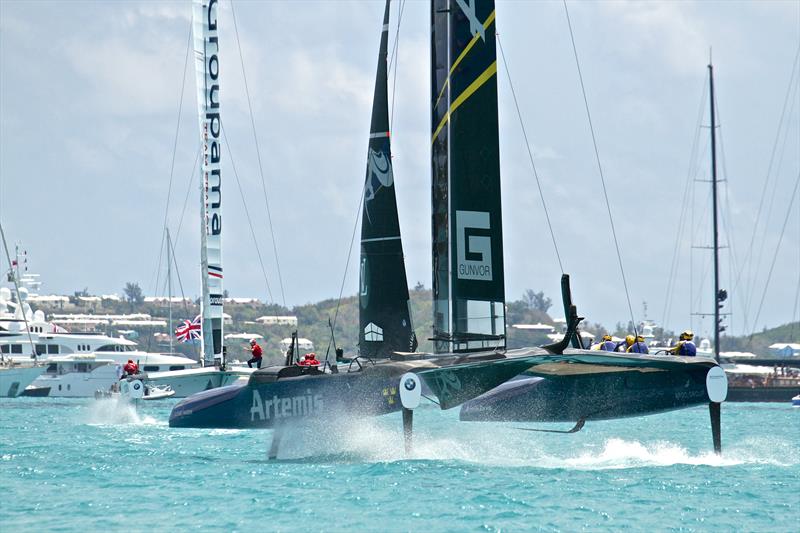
[460,367,709,422]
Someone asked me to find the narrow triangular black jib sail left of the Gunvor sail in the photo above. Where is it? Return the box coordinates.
[358,0,417,357]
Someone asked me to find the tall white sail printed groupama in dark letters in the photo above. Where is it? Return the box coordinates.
[192,0,223,364]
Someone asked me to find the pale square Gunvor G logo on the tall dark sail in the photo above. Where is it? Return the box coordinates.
[456,211,492,281]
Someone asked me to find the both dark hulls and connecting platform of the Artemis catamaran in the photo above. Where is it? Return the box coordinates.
[169,348,715,429]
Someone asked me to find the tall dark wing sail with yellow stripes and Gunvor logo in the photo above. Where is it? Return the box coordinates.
[431,0,505,352]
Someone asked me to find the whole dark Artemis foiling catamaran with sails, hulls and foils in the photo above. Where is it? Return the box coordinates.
[169,0,727,457]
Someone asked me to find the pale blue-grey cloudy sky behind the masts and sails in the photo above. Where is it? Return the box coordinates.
[0,0,800,334]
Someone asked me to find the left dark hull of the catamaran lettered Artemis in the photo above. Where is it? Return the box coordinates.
[169,350,543,429]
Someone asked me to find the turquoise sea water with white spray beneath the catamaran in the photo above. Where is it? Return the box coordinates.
[0,398,800,532]
